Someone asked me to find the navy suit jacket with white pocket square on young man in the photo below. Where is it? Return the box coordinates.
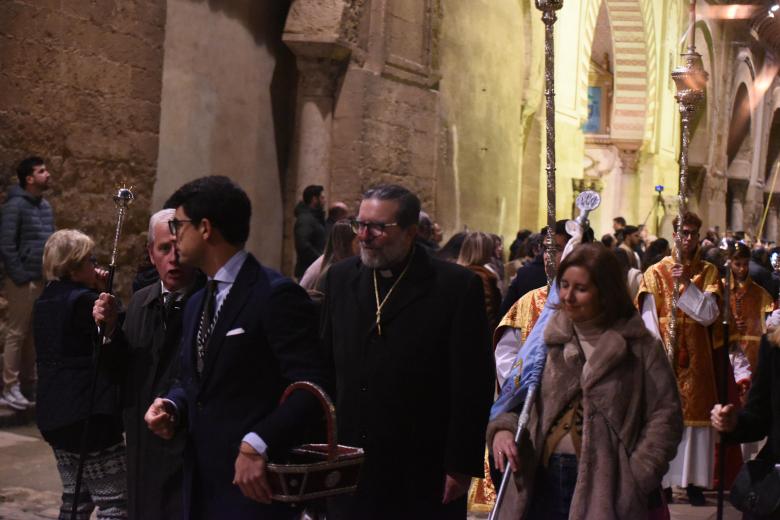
[167,255,325,519]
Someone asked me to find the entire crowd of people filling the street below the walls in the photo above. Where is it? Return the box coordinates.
[0,157,780,520]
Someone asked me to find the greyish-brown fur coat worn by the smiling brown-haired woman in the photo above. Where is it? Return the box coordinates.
[488,311,683,520]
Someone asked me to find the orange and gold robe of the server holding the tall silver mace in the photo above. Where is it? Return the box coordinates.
[637,251,720,426]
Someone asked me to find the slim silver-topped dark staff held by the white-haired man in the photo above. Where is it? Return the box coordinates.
[70,187,135,520]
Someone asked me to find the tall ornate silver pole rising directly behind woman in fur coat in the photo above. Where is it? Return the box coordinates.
[535,0,563,286]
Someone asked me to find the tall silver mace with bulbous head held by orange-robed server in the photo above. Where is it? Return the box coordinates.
[666,0,709,363]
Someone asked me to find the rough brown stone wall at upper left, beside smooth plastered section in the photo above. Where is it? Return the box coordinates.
[0,0,166,295]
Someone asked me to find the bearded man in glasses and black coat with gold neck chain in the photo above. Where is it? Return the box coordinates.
[323,185,494,520]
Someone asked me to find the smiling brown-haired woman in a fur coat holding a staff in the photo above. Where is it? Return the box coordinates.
[488,244,683,520]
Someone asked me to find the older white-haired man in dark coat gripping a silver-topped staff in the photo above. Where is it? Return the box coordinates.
[92,209,203,520]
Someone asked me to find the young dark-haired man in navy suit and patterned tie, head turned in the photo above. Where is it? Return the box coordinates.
[145,176,324,520]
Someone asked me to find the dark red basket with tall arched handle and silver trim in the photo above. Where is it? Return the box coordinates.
[268,381,364,503]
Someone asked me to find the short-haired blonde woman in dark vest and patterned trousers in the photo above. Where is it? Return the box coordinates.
[33,229,127,519]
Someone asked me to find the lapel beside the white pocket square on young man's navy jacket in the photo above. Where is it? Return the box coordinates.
[201,255,268,388]
